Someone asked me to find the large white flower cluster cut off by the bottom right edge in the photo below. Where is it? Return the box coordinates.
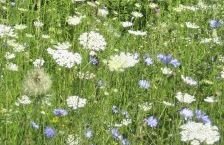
[180,121,220,145]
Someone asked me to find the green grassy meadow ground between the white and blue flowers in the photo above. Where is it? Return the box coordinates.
[0,0,224,145]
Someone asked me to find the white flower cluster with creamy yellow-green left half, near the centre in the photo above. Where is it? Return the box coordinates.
[108,52,139,71]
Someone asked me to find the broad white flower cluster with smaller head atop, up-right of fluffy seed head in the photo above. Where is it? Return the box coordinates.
[47,43,82,68]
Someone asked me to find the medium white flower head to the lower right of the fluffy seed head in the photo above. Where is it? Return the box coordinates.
[66,96,86,110]
